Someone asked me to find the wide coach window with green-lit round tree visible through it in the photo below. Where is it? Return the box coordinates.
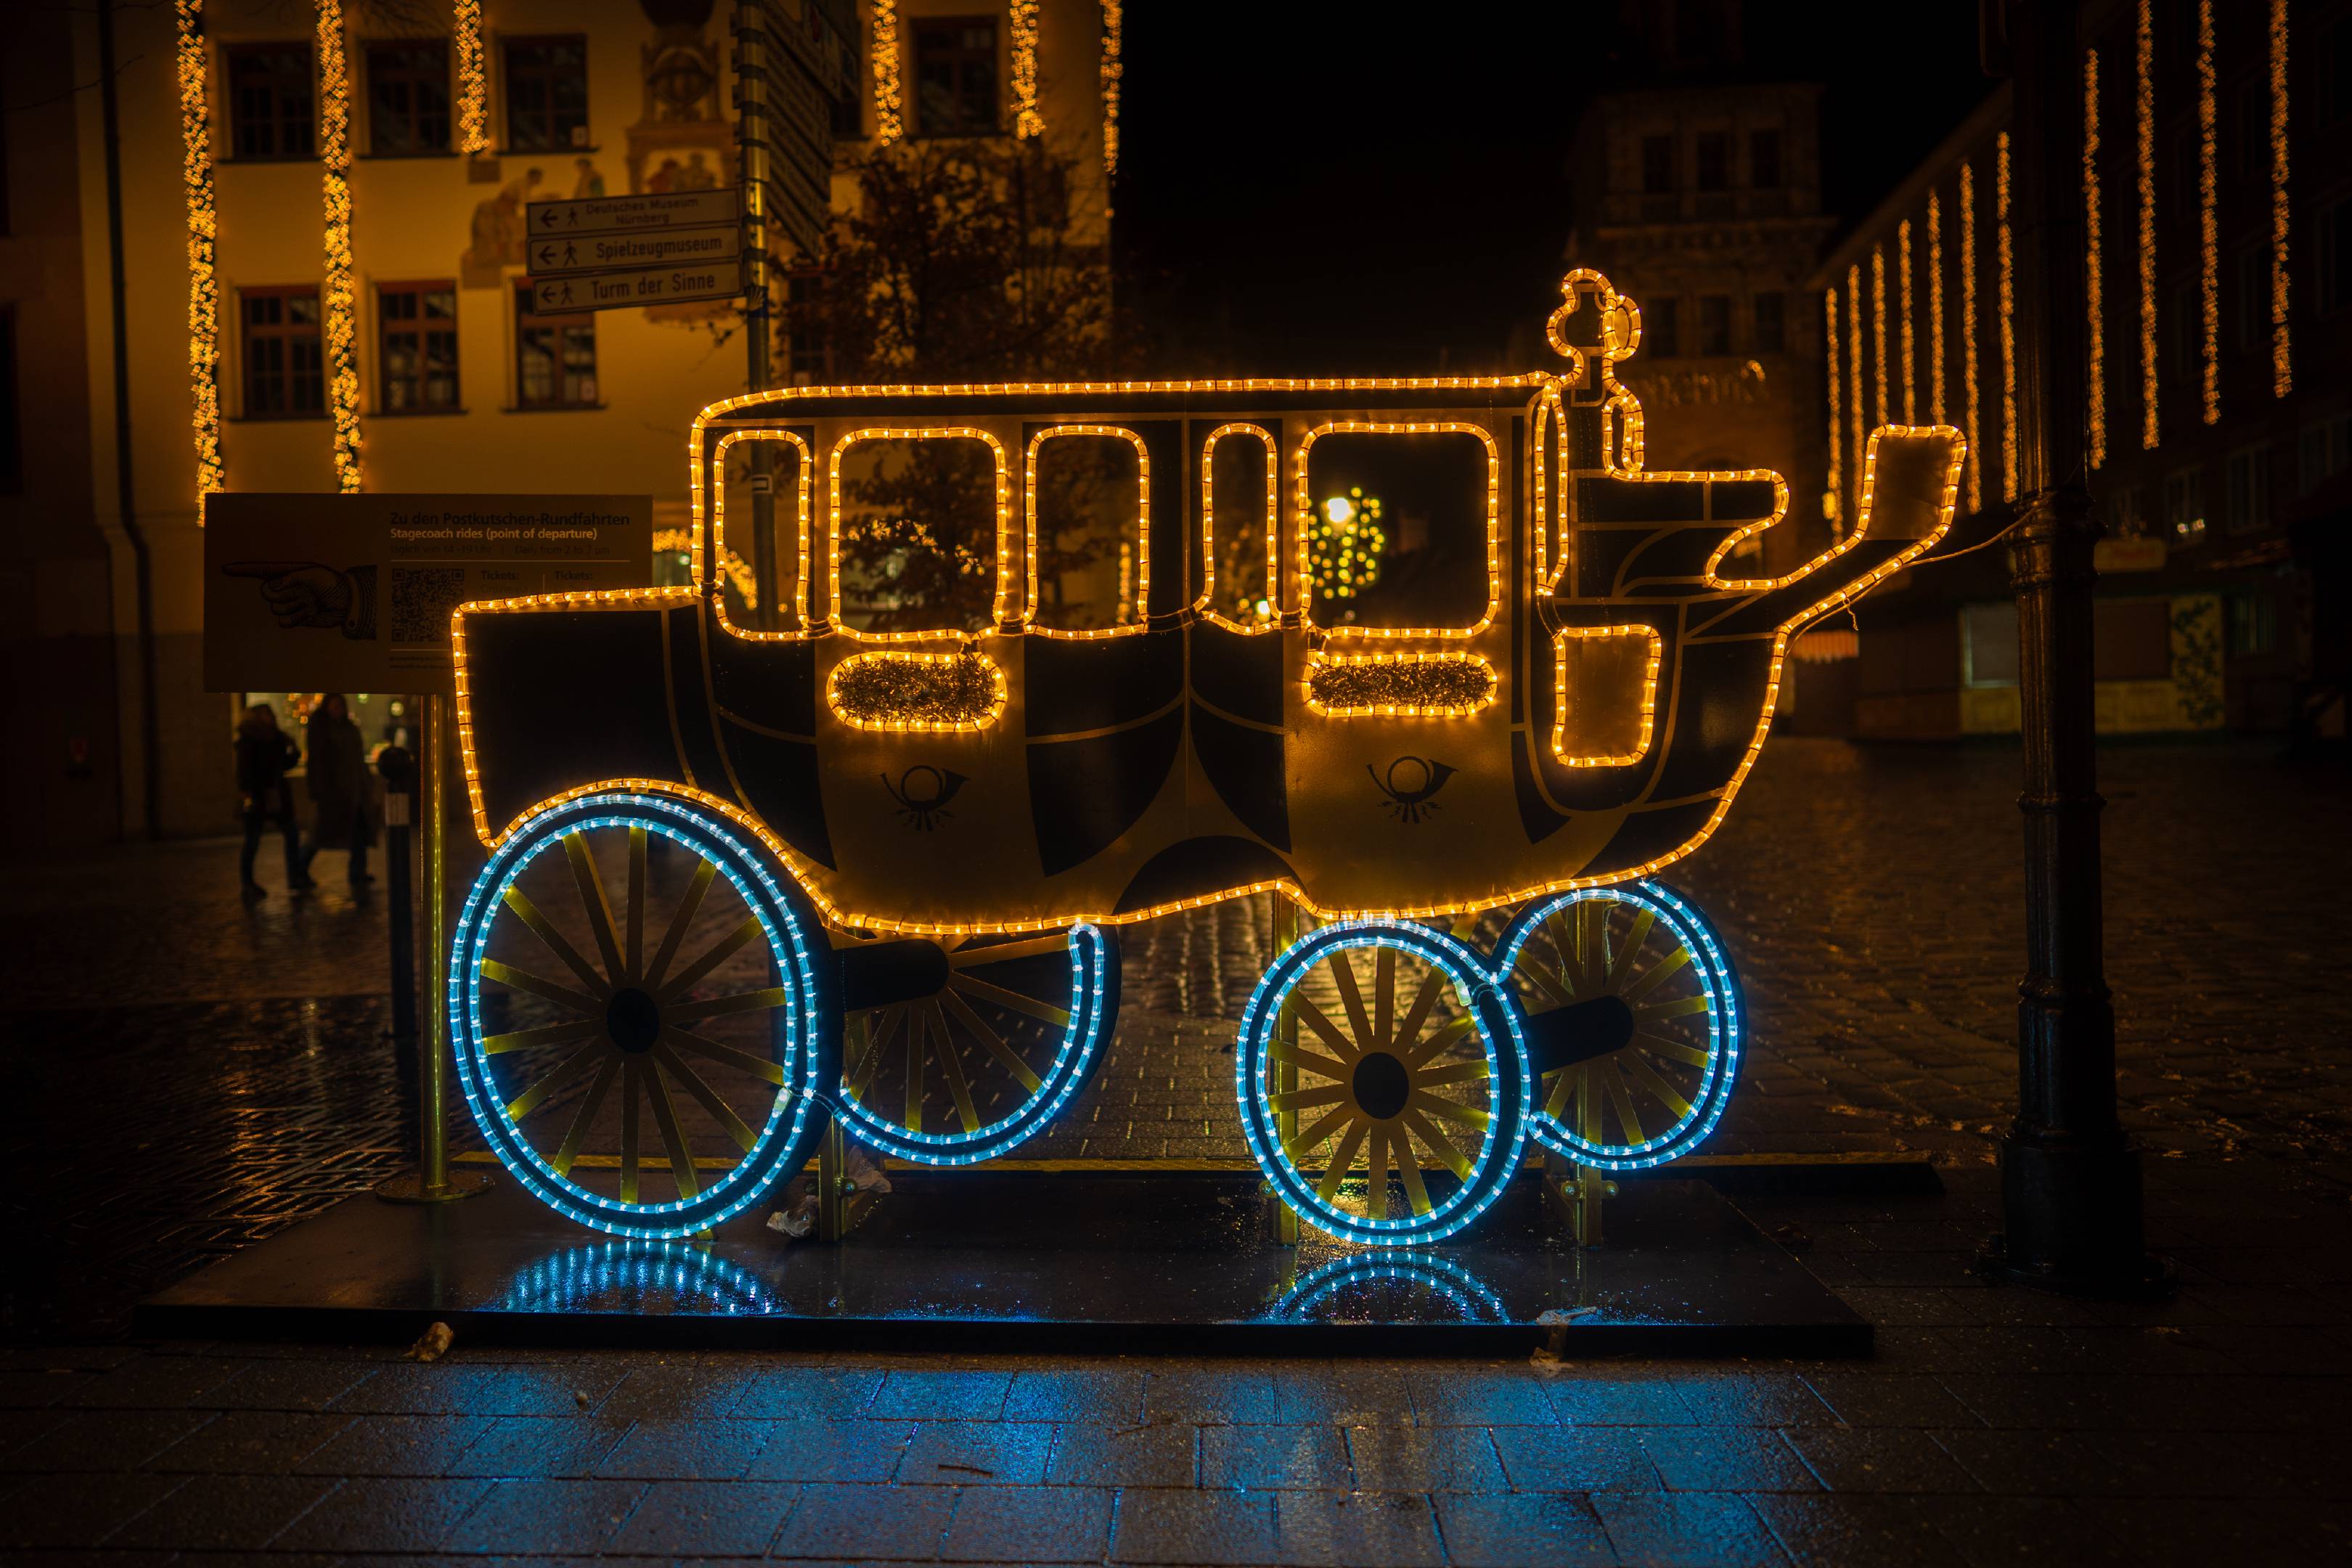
[1298,428,1496,630]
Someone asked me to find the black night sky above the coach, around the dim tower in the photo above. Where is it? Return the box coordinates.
[1117,0,1992,374]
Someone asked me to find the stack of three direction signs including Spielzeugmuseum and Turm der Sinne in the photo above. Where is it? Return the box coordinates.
[525,188,743,315]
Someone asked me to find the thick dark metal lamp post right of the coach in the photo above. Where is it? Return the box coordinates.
[1990,0,2152,1293]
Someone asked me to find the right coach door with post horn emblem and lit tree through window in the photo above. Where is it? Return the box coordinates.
[1289,412,1515,910]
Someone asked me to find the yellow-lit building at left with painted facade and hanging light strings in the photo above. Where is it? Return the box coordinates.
[0,0,1119,849]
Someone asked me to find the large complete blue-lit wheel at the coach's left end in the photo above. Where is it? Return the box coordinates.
[449,792,835,1239]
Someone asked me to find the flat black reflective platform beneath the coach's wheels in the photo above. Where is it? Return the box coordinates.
[134,1171,1870,1357]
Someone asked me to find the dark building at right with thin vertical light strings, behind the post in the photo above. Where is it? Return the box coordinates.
[1811,0,2352,738]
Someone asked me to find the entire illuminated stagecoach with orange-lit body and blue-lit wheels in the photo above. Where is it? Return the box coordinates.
[437,266,1966,1246]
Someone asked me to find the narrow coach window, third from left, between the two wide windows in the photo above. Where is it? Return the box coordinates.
[1028,428,1150,632]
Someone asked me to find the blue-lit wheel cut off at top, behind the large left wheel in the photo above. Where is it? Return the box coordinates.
[840,926,1119,1166]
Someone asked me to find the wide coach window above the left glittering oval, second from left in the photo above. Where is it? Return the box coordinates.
[833,435,1007,634]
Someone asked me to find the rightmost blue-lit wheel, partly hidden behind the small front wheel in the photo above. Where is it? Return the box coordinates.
[1498,881,1743,1171]
